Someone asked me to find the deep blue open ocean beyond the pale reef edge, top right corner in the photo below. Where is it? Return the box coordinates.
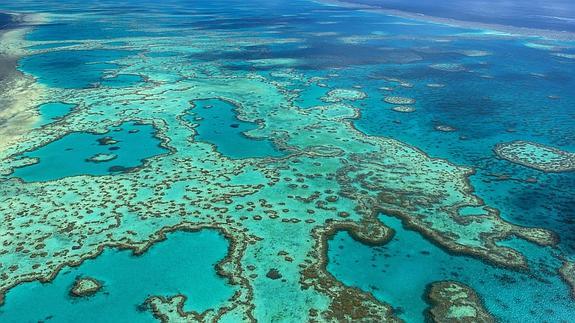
[344,0,575,32]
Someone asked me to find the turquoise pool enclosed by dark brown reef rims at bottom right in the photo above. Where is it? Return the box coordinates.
[328,215,575,322]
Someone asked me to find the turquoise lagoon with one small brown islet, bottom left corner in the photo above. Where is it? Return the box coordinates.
[0,230,234,322]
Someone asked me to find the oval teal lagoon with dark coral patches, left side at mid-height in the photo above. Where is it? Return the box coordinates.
[12,122,167,182]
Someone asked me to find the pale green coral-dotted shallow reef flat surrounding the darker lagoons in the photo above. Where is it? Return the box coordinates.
[0,3,568,322]
